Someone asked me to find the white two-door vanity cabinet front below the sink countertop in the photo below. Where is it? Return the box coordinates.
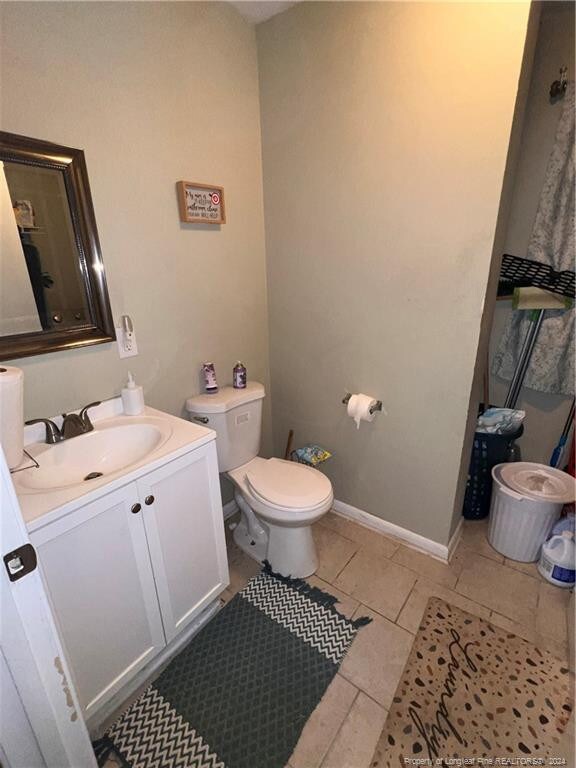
[30,442,228,717]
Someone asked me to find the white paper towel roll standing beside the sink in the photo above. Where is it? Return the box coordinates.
[0,365,24,469]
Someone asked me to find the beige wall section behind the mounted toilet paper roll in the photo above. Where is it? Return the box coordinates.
[258,3,529,544]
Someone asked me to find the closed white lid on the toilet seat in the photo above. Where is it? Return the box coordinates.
[246,459,332,509]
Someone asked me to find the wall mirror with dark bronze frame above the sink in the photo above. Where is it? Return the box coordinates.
[0,131,115,360]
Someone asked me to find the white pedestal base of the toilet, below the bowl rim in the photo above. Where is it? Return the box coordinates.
[233,509,318,579]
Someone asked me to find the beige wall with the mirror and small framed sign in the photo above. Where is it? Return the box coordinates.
[0,2,269,468]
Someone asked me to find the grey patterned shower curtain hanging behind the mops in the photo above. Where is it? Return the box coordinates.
[492,83,575,395]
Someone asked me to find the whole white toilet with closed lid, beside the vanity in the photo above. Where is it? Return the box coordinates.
[186,381,334,578]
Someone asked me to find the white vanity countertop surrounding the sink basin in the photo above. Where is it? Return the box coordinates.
[12,398,216,532]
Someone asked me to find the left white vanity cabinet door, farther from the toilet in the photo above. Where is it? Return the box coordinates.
[30,483,165,716]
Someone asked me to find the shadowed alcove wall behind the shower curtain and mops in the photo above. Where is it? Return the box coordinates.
[490,2,575,464]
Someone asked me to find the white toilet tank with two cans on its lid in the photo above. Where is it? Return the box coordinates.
[186,381,266,472]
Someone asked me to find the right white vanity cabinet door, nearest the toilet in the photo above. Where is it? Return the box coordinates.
[137,442,229,642]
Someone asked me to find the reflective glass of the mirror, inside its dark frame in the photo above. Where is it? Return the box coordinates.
[0,162,89,335]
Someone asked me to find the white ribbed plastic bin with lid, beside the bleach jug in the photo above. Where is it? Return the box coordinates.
[488,461,574,563]
